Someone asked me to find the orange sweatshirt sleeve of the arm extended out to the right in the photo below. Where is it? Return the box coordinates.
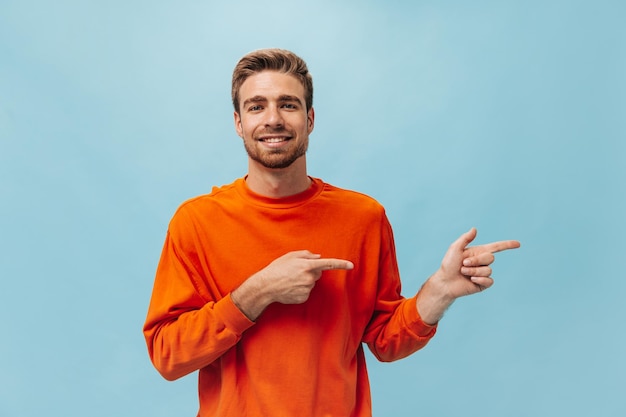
[364,216,437,362]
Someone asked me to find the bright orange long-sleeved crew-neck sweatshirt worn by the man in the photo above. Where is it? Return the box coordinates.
[143,179,436,417]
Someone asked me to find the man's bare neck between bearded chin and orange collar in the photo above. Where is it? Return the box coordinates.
[246,157,311,198]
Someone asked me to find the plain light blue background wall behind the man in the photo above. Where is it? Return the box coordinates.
[0,0,626,417]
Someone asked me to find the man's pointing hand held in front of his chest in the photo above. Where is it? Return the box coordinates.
[231,250,354,321]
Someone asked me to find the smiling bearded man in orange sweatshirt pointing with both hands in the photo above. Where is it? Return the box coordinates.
[144,49,519,417]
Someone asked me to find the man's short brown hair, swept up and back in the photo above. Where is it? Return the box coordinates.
[231,48,313,113]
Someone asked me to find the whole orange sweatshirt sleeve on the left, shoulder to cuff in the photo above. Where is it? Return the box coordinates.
[143,218,254,380]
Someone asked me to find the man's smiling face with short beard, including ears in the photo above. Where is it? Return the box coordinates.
[235,71,314,169]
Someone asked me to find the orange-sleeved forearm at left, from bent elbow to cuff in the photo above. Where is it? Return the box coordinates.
[144,297,254,380]
